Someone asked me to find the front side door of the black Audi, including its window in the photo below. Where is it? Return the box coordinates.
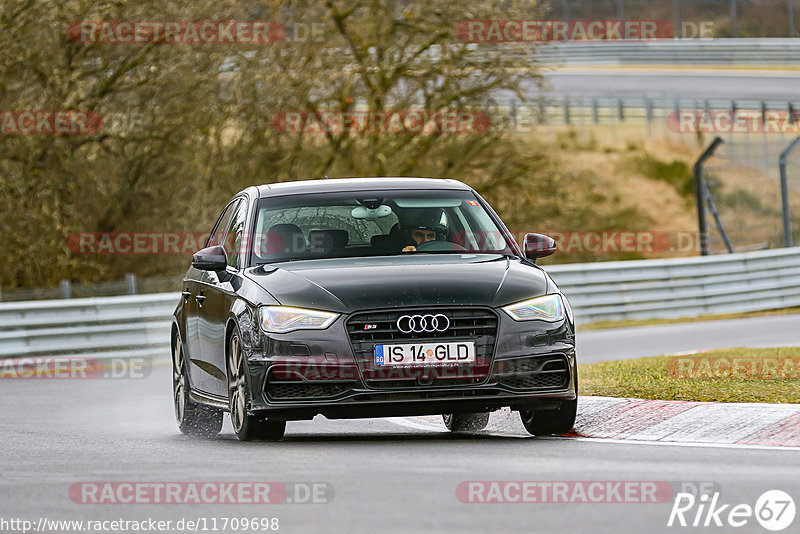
[198,199,247,396]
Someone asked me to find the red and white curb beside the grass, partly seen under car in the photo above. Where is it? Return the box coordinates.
[388,397,800,450]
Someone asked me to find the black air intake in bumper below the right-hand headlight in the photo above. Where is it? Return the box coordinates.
[495,355,569,389]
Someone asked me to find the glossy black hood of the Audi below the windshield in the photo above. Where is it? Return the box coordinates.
[247,254,548,313]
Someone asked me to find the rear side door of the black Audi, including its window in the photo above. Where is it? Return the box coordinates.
[183,199,239,393]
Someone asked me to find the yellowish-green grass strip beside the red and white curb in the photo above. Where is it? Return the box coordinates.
[578,347,800,403]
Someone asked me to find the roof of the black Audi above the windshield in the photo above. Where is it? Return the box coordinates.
[256,177,472,198]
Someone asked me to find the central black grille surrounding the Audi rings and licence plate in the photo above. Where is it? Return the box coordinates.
[347,307,498,388]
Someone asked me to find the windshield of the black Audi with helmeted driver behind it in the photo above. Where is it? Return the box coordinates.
[252,191,514,264]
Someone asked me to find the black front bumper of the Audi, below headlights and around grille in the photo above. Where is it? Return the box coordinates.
[248,313,576,420]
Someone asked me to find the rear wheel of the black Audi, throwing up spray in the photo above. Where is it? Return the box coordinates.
[172,334,222,438]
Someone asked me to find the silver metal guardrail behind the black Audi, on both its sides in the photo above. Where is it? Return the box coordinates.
[0,247,800,359]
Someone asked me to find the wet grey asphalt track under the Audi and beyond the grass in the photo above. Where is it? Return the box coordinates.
[0,316,800,533]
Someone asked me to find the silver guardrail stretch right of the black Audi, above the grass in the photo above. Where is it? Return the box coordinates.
[546,247,800,324]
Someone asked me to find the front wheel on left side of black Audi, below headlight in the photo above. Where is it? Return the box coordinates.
[228,329,286,441]
